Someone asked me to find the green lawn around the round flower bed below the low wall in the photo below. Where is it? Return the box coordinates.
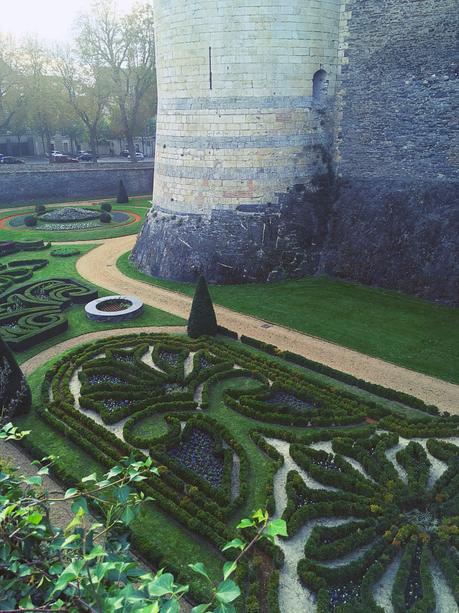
[0,198,150,242]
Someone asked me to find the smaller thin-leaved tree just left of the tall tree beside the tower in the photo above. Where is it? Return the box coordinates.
[56,49,110,162]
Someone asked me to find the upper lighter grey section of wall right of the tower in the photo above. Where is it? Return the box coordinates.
[338,0,459,180]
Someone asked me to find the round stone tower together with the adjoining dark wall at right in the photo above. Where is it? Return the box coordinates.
[133,0,459,302]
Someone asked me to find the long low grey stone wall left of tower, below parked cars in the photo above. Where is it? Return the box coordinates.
[0,162,153,208]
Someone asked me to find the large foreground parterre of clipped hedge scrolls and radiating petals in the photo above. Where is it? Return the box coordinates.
[40,334,459,613]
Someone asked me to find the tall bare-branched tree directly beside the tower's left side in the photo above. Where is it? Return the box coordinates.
[78,0,156,163]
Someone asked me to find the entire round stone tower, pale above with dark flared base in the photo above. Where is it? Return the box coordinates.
[132,0,341,283]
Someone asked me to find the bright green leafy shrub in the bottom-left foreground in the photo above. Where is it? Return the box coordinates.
[0,424,287,613]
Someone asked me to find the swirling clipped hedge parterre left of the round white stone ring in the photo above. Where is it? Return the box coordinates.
[0,278,97,351]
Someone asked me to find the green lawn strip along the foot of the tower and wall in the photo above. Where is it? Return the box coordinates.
[117,254,459,383]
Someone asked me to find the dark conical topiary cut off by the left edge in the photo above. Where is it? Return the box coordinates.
[0,337,32,424]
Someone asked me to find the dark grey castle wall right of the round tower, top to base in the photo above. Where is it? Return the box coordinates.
[324,0,459,303]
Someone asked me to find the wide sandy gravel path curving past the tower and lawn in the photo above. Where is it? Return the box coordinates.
[73,236,459,414]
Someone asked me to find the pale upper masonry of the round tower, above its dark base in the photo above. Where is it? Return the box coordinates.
[154,0,340,215]
